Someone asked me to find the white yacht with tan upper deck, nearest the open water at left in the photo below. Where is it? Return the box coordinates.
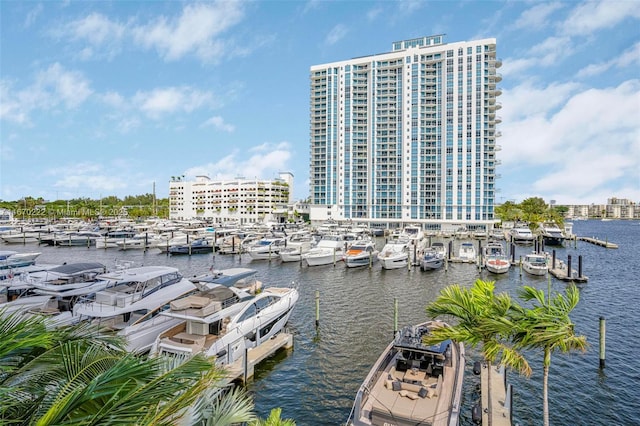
[151,270,299,366]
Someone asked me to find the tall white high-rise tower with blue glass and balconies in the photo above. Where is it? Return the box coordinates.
[309,35,502,229]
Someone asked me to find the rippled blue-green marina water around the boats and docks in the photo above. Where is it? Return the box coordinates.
[4,221,640,426]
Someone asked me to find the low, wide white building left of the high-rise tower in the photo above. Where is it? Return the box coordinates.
[169,172,293,224]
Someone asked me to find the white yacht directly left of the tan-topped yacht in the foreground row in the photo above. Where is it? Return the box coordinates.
[74,266,195,352]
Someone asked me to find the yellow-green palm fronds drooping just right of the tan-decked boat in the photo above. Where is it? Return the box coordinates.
[425,280,531,376]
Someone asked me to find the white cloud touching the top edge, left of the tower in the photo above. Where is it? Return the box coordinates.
[132,1,244,62]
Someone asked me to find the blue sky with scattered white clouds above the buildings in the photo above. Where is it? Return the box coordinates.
[0,0,640,204]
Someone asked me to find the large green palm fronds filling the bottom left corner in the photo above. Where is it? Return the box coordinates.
[0,312,252,425]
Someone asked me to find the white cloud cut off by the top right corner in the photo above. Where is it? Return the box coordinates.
[560,0,640,36]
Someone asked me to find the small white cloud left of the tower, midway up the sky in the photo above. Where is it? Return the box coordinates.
[133,87,213,119]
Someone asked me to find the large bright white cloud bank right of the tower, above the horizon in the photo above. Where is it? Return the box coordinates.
[499,80,640,203]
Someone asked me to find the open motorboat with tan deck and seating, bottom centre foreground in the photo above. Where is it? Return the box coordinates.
[347,321,465,426]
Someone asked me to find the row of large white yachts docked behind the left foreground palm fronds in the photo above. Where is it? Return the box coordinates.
[0,263,298,365]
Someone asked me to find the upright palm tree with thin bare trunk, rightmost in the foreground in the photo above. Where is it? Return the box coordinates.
[512,285,587,426]
